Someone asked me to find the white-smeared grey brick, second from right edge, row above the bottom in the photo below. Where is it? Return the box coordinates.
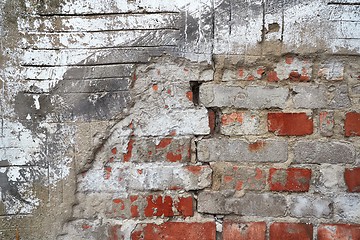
[289,195,332,218]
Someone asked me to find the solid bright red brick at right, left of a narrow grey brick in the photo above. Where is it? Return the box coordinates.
[268,113,314,136]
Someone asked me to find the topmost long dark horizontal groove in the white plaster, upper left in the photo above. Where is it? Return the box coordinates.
[32,11,181,17]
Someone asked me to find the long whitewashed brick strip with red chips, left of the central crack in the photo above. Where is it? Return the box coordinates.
[78,163,212,192]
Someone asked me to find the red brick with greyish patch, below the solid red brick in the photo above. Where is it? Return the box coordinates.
[269,168,311,192]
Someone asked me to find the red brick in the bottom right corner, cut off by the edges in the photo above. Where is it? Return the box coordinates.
[318,224,360,240]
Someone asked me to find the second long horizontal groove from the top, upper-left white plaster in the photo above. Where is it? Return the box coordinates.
[20,27,180,35]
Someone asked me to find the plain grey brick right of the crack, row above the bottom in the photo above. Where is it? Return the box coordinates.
[225,193,286,217]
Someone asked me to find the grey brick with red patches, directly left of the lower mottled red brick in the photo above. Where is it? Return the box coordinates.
[211,163,266,191]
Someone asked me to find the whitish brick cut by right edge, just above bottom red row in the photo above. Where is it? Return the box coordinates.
[334,193,360,222]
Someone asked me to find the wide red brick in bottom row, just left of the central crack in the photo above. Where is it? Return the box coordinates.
[131,222,216,240]
